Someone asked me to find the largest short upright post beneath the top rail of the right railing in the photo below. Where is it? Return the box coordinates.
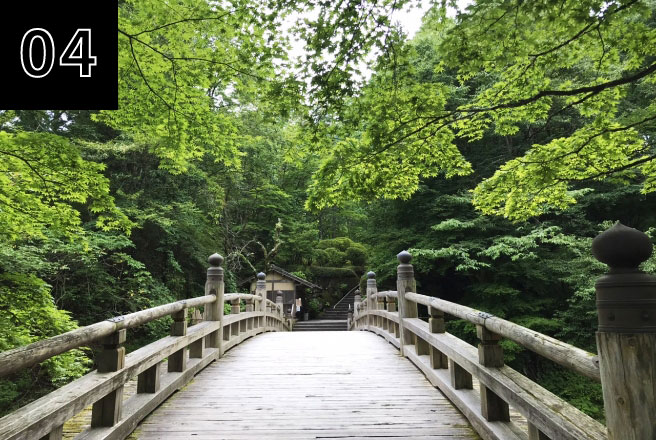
[476,324,510,422]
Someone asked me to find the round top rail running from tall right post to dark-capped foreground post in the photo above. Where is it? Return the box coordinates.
[405,292,601,382]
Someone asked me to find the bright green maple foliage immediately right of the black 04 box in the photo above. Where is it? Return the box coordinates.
[96,0,294,173]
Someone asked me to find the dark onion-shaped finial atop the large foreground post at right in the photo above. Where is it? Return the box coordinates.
[592,222,653,270]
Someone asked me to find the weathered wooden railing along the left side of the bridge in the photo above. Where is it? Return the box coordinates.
[0,254,289,440]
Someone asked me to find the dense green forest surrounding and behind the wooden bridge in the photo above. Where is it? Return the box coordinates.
[0,0,656,419]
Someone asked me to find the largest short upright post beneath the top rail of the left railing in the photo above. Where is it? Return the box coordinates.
[91,329,126,428]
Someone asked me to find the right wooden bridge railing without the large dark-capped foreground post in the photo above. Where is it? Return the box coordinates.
[349,252,612,440]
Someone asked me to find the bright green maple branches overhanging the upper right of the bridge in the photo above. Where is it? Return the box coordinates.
[307,0,656,220]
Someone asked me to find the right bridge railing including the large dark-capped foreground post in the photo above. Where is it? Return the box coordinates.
[350,223,656,440]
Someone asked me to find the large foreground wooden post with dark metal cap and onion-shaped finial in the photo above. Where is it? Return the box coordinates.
[592,222,656,440]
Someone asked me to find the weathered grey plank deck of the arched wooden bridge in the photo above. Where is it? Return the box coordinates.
[130,332,479,440]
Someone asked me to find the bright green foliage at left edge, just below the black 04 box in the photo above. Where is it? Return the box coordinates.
[0,129,131,242]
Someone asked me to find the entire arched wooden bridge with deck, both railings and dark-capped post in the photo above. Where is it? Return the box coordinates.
[0,224,656,440]
